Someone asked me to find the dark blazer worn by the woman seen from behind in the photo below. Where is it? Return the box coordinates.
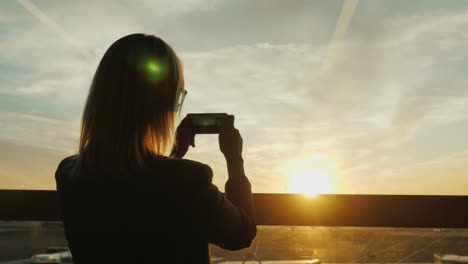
[55,155,257,264]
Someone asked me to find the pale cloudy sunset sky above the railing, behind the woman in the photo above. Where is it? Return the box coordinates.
[0,0,468,195]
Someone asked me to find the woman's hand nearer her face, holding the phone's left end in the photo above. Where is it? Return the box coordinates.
[170,117,195,159]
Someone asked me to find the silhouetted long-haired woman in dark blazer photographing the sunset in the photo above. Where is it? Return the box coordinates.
[55,34,257,264]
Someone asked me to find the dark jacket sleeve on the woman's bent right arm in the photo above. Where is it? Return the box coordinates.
[201,165,257,250]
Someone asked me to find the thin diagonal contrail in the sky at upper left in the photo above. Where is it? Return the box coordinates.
[18,0,91,59]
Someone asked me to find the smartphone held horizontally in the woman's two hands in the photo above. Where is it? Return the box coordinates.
[187,113,227,134]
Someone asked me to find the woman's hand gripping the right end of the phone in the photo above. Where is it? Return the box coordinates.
[218,115,243,162]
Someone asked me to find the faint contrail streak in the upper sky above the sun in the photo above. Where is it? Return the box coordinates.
[322,0,359,72]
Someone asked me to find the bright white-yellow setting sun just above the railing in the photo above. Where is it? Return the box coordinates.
[281,154,338,196]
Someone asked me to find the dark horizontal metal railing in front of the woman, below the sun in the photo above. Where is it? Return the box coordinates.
[0,190,468,228]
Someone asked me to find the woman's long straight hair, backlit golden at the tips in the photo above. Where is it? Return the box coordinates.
[78,34,184,174]
